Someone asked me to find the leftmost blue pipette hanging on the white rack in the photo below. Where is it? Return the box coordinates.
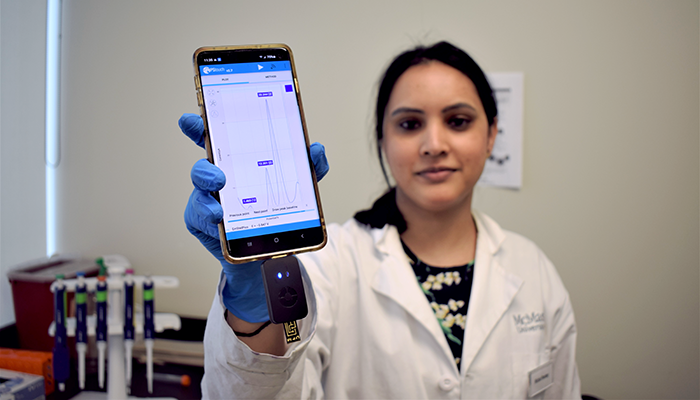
[53,274,70,392]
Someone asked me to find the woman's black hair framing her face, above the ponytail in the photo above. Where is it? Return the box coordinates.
[375,42,498,186]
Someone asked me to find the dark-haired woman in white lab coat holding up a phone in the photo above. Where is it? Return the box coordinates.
[180,42,580,398]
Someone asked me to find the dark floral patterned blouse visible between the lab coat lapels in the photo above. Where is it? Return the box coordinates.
[401,241,474,370]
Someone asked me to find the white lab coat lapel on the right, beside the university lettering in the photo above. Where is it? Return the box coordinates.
[462,213,523,371]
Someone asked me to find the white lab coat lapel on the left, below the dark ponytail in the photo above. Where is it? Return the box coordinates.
[371,225,452,358]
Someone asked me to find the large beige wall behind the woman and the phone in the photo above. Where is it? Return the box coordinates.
[50,0,700,398]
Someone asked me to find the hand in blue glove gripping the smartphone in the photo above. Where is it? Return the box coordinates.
[178,114,329,322]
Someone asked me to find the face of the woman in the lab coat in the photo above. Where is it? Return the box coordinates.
[382,61,497,212]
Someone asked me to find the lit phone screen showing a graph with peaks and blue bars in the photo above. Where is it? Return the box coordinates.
[202,63,320,239]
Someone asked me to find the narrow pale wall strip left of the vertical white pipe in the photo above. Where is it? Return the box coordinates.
[0,0,46,328]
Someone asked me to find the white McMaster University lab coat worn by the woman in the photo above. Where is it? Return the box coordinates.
[202,212,581,399]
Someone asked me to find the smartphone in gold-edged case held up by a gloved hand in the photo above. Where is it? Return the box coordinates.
[193,44,327,264]
